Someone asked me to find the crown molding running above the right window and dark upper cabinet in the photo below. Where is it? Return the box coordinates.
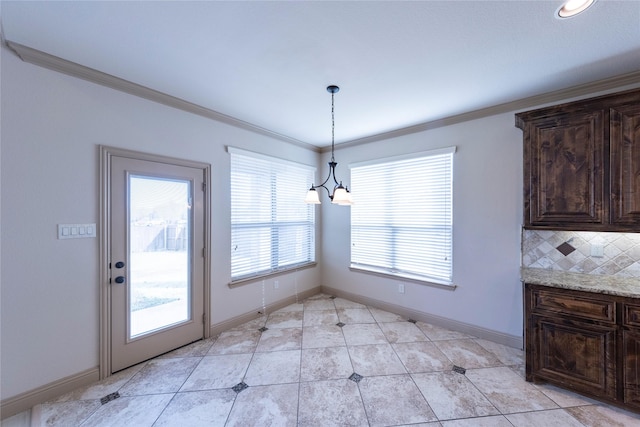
[320,71,640,153]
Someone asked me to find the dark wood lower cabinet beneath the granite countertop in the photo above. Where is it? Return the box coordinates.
[525,284,640,412]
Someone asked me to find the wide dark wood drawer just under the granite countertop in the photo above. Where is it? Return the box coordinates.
[531,289,616,324]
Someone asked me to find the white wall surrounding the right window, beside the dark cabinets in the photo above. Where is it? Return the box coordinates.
[322,113,522,337]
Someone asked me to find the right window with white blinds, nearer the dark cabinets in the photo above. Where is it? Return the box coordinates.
[351,147,455,285]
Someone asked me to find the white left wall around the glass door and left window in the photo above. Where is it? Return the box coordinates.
[0,46,321,399]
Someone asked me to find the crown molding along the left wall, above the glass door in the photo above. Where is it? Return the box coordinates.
[5,40,320,152]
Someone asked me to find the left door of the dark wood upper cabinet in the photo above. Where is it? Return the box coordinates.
[528,110,607,225]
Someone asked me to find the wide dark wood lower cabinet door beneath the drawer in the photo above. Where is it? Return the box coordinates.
[532,316,616,399]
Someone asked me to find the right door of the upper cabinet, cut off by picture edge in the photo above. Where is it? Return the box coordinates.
[610,104,640,225]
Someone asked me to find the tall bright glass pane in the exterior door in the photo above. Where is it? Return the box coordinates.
[128,175,191,338]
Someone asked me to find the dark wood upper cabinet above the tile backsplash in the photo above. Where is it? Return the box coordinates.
[516,90,640,231]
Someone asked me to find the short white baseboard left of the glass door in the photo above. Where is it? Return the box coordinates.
[0,367,100,419]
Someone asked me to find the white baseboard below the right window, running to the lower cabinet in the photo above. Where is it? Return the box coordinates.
[322,286,524,350]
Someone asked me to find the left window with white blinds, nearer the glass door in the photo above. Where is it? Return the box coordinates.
[228,147,315,282]
